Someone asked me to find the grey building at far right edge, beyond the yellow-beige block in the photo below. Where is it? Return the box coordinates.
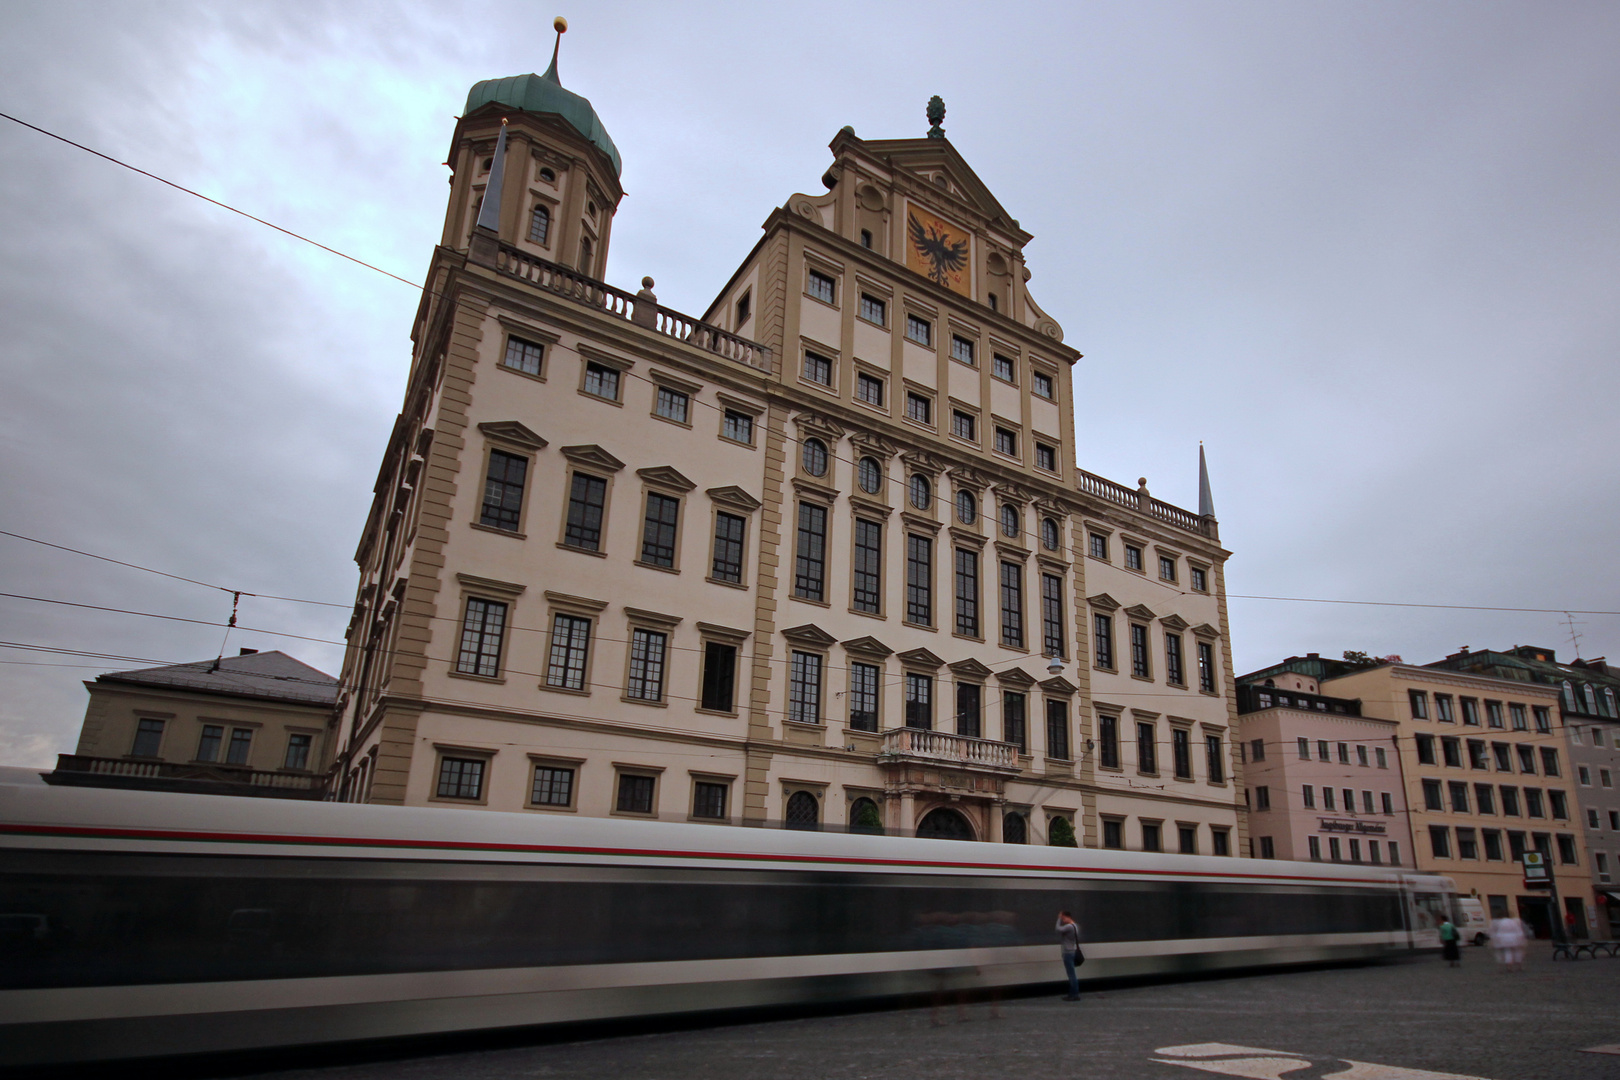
[1430,644,1620,939]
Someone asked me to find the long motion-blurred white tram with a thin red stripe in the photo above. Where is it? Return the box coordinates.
[0,779,1453,1065]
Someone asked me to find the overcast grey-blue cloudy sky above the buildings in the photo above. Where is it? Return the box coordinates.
[0,0,1620,764]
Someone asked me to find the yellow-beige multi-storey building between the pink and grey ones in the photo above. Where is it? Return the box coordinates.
[1244,656,1588,938]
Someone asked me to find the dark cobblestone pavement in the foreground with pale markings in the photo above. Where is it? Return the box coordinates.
[246,949,1620,1080]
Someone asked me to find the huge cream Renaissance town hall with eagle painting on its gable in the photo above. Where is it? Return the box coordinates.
[332,46,1244,855]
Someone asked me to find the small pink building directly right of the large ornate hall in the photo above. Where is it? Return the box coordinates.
[1238,672,1413,866]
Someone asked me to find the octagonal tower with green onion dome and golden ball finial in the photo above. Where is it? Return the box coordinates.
[441,18,624,279]
